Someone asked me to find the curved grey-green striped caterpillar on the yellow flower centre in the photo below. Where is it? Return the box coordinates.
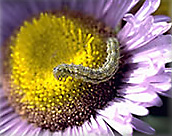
[53,37,120,84]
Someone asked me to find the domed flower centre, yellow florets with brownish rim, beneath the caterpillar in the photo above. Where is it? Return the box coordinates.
[4,12,117,131]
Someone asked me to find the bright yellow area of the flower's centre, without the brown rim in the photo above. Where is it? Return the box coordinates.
[10,13,107,113]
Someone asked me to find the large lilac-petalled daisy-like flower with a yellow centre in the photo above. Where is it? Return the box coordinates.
[0,0,172,136]
